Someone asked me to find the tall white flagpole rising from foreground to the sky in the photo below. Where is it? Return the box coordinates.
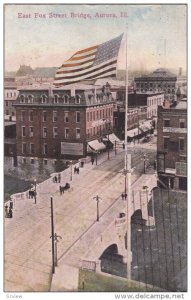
[124,24,132,280]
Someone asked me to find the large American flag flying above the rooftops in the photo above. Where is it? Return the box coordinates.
[54,34,123,87]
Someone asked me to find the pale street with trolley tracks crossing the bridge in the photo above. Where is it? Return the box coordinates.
[5,144,157,291]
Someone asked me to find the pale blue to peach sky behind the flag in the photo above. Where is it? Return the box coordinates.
[4,4,187,71]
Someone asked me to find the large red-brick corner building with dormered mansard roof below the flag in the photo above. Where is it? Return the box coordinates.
[15,84,113,164]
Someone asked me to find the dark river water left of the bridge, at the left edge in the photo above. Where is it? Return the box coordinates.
[4,175,33,202]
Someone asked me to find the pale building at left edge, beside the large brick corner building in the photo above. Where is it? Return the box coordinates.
[4,77,18,120]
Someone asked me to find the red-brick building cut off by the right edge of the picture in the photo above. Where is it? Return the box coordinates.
[157,99,187,190]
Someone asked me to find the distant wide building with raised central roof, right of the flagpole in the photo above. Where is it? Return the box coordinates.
[134,68,177,101]
